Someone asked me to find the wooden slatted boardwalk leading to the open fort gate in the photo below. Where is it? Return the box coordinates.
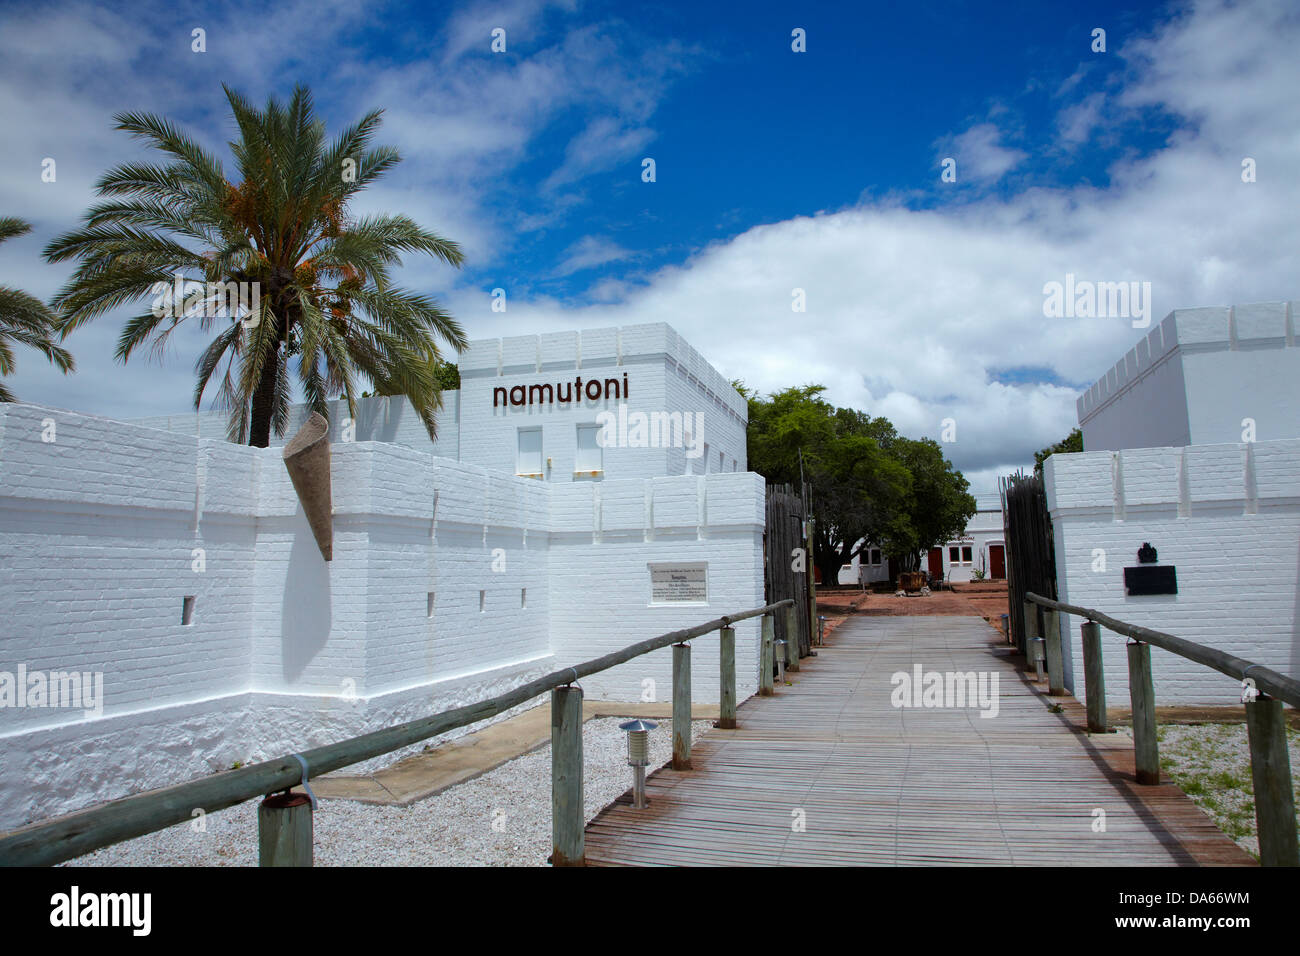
[586,617,1253,866]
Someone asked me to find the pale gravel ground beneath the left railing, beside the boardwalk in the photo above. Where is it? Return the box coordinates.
[65,717,712,866]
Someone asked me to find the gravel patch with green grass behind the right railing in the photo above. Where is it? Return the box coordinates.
[1119,723,1300,860]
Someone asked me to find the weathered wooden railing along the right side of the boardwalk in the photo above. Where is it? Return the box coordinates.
[1024,592,1300,866]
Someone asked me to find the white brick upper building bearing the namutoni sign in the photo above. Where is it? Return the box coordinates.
[135,323,749,483]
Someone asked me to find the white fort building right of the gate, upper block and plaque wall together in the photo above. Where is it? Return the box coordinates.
[1044,302,1300,706]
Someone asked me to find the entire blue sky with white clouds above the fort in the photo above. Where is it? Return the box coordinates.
[0,0,1300,492]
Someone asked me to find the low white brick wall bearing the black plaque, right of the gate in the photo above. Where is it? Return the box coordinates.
[1044,440,1300,708]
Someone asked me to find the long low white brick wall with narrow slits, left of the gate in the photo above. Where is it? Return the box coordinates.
[0,405,763,827]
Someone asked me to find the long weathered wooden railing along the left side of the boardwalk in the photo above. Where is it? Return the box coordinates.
[0,600,798,866]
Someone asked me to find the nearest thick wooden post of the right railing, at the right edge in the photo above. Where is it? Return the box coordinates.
[1245,696,1300,866]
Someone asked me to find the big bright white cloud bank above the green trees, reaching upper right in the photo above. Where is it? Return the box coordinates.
[441,4,1300,493]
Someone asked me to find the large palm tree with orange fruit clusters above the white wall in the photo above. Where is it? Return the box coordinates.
[46,87,467,447]
